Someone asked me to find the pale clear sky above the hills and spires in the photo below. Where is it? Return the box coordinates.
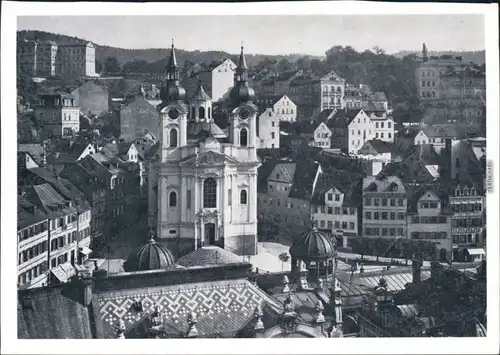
[18,15,485,55]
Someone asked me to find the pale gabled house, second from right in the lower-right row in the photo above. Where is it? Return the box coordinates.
[407,187,452,261]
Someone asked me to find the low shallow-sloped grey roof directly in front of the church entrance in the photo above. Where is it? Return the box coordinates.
[177,246,243,267]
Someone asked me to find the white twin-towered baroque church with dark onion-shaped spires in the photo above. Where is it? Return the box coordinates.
[148,44,260,255]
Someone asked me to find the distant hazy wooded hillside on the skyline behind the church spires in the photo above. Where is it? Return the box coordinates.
[17,30,316,71]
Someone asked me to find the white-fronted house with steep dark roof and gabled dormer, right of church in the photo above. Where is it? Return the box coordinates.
[311,171,361,247]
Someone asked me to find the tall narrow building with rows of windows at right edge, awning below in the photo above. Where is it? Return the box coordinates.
[450,183,486,261]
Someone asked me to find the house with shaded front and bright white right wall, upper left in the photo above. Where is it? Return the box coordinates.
[35,92,80,139]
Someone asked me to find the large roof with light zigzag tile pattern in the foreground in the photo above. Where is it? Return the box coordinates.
[94,279,282,338]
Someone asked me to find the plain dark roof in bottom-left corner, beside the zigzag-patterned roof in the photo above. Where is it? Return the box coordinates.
[17,283,93,339]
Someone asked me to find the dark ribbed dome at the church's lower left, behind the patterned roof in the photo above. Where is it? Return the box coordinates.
[123,236,175,272]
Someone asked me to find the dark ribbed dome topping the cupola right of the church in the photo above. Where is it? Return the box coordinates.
[290,227,335,260]
